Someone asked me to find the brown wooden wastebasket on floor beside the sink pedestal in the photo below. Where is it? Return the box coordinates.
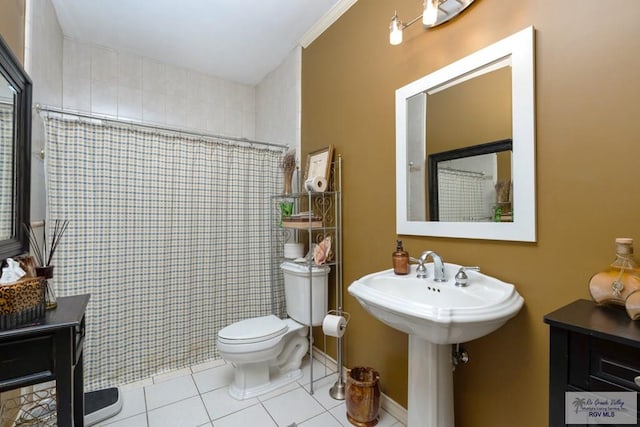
[346,366,380,427]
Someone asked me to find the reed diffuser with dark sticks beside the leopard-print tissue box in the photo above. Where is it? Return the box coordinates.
[23,219,69,310]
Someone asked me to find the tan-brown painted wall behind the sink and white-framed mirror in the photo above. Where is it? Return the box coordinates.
[302,0,640,427]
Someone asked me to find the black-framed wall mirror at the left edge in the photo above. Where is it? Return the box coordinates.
[0,37,31,261]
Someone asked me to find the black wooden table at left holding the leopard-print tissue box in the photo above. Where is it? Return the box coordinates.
[0,295,89,427]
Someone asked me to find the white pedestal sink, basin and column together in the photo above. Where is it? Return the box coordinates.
[348,263,524,427]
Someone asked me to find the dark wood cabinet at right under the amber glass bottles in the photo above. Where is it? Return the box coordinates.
[544,300,640,427]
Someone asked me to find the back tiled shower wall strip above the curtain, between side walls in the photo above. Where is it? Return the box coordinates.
[62,38,255,139]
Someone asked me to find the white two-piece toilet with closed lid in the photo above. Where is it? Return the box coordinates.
[216,262,330,400]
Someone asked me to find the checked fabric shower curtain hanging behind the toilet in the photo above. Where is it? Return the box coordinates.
[45,117,284,390]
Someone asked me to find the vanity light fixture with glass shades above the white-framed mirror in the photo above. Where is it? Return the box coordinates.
[389,0,474,46]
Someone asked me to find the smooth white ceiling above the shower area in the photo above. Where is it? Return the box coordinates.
[52,0,355,85]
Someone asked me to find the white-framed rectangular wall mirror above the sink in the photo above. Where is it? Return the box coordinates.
[396,27,536,242]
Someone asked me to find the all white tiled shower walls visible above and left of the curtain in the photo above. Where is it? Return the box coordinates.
[25,0,301,220]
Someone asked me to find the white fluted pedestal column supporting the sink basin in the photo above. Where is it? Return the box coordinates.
[408,335,454,427]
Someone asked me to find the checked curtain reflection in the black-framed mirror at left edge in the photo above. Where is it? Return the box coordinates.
[0,100,15,240]
